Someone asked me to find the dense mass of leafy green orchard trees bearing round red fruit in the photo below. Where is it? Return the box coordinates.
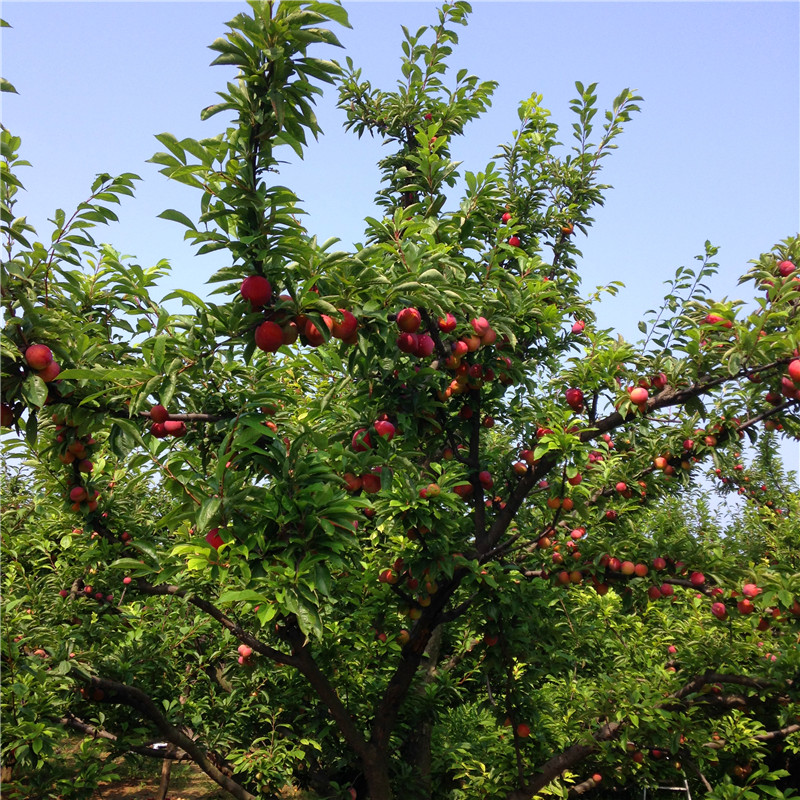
[2,2,800,800]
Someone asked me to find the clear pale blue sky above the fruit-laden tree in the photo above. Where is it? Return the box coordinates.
[2,0,800,476]
